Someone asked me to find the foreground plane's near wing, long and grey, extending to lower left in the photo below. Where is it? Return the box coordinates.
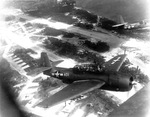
[36,81,105,107]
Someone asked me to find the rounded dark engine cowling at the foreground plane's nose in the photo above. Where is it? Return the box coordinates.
[108,75,133,91]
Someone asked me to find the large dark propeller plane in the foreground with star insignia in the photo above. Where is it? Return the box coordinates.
[36,52,133,107]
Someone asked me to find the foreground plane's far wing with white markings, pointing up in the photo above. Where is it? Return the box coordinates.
[104,54,127,71]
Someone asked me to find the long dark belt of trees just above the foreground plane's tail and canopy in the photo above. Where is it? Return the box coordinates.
[44,38,104,63]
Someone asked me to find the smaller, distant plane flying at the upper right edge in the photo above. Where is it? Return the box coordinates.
[112,16,150,30]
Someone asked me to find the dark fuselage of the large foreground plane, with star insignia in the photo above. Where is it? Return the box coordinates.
[44,67,132,91]
